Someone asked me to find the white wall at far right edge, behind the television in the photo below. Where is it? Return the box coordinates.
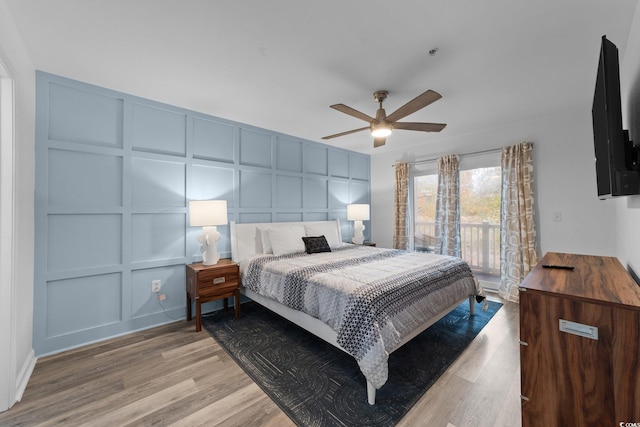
[616,0,640,274]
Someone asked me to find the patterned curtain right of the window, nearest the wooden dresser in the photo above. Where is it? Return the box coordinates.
[499,142,538,302]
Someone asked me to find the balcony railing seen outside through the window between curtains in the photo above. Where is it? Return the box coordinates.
[414,221,500,275]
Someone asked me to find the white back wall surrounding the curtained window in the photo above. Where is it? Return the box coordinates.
[371,108,616,255]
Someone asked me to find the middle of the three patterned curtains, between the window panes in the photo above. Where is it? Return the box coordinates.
[435,154,461,257]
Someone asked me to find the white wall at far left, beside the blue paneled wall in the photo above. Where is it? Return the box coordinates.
[0,0,35,411]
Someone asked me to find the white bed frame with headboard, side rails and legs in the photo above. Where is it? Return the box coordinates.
[231,220,475,405]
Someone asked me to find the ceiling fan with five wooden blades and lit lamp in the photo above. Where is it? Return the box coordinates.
[322,90,446,147]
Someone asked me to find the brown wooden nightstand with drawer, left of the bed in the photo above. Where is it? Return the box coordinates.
[187,259,240,332]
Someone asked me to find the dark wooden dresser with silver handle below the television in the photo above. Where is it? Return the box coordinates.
[520,253,640,427]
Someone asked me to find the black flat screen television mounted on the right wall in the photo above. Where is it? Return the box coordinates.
[591,36,640,199]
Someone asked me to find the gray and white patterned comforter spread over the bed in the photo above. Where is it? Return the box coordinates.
[241,245,481,388]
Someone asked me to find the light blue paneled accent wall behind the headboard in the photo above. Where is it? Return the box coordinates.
[33,72,371,356]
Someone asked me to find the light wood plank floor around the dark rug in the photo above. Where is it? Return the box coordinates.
[0,298,520,427]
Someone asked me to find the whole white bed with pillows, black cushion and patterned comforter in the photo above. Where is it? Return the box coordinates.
[231,220,482,405]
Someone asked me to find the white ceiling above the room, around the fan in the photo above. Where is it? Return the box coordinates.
[4,0,637,153]
